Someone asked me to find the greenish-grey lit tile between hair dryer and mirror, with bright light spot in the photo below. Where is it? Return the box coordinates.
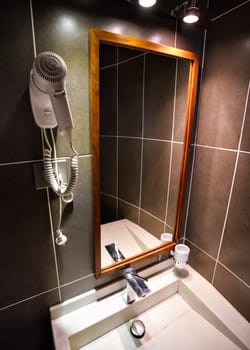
[32,0,91,156]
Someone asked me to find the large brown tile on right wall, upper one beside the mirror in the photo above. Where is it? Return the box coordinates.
[198,3,250,149]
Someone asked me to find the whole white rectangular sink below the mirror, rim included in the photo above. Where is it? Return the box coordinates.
[51,263,250,350]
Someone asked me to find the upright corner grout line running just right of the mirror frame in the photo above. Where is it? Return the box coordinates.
[183,29,207,241]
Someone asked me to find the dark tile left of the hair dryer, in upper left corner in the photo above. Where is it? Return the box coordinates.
[0,1,42,163]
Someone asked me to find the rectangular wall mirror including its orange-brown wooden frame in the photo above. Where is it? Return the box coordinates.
[90,30,198,277]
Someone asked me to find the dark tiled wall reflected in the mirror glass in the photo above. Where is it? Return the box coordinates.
[100,44,190,239]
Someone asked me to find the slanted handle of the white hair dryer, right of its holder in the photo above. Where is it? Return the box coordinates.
[50,89,74,142]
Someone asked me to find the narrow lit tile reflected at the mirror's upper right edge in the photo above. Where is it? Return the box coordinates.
[174,59,190,142]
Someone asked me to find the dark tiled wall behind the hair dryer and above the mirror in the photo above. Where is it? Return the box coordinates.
[0,0,203,350]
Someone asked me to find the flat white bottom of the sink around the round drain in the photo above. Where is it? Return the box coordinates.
[80,294,240,350]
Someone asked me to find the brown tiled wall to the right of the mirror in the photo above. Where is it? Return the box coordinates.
[186,0,250,321]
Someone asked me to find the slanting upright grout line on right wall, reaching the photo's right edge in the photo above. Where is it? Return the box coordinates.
[212,80,250,284]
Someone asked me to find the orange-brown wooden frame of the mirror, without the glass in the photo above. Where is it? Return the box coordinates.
[90,29,199,278]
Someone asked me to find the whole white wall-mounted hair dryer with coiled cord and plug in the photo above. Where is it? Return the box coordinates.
[29,51,78,245]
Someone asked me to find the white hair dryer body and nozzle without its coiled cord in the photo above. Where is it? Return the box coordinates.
[29,51,73,142]
